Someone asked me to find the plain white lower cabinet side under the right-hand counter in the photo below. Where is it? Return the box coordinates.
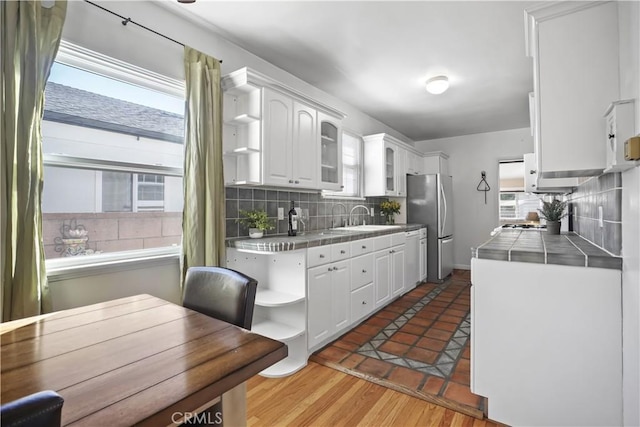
[471,258,622,426]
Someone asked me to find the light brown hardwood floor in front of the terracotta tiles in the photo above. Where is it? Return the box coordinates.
[247,362,499,427]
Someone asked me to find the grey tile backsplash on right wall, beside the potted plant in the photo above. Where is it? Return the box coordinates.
[569,173,622,255]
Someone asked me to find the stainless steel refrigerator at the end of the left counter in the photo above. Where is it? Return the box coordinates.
[407,174,453,282]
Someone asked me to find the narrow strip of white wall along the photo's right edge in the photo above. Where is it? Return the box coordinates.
[618,2,640,426]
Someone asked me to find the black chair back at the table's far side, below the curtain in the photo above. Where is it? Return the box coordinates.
[182,267,258,329]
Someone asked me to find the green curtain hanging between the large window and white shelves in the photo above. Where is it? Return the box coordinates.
[182,46,226,277]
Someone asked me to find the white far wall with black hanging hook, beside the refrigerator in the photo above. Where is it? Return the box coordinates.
[415,128,533,269]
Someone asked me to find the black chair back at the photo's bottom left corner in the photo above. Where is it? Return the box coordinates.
[0,390,64,427]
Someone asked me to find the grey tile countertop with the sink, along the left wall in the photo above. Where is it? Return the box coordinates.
[226,224,425,252]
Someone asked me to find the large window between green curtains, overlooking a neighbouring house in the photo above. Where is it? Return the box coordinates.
[42,42,184,263]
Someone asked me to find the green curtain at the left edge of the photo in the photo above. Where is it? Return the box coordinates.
[0,1,67,321]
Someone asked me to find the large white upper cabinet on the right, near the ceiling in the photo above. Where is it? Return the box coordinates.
[526,2,619,178]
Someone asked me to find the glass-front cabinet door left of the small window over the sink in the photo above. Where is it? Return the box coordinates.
[318,112,342,191]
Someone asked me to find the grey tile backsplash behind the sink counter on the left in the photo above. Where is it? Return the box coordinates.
[225,187,387,237]
